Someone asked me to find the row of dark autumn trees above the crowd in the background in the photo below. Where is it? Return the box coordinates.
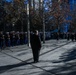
[0,0,76,44]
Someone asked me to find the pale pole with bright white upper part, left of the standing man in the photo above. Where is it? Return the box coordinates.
[27,2,30,46]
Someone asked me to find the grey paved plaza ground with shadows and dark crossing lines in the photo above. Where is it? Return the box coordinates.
[0,40,76,75]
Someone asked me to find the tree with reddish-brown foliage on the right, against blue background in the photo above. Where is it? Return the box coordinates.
[48,0,70,31]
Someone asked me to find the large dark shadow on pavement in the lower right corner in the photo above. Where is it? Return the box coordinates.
[41,48,76,75]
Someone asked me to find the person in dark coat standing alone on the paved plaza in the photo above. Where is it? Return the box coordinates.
[30,30,41,63]
